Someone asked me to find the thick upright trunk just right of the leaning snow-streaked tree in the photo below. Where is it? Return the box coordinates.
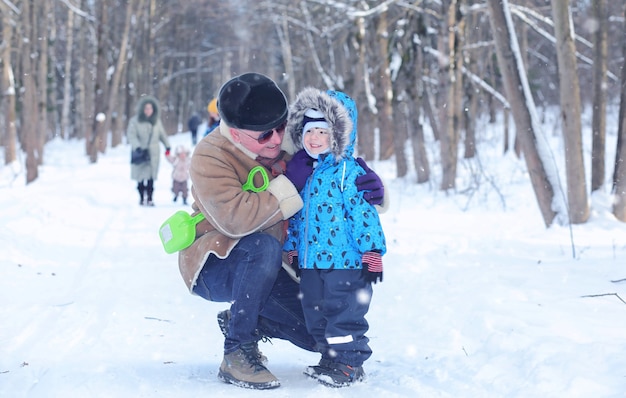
[552,0,589,224]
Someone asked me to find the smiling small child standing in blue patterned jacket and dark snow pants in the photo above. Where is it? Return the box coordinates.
[283,88,386,387]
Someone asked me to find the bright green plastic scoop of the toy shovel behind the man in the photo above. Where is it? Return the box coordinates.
[159,210,204,254]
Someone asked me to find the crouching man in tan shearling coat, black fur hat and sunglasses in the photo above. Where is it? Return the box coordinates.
[173,73,382,389]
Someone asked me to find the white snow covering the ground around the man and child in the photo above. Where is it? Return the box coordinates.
[0,112,626,398]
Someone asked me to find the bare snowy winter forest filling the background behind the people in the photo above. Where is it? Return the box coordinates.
[0,0,626,226]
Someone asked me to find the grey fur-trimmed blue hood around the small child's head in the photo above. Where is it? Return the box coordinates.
[286,87,357,162]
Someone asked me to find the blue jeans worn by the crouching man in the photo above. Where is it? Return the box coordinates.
[193,232,315,353]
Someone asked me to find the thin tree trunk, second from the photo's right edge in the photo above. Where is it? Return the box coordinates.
[591,0,609,191]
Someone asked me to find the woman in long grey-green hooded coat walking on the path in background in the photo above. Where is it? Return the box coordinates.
[126,96,170,206]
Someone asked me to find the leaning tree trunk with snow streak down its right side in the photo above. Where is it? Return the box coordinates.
[487,0,557,226]
